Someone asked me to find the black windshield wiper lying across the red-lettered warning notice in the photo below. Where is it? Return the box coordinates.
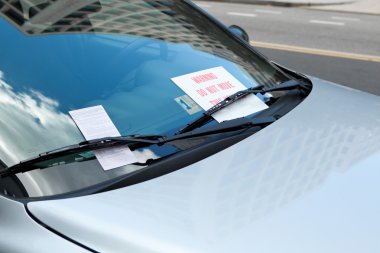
[175,79,308,135]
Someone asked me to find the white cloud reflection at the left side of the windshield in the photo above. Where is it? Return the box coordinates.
[0,71,83,166]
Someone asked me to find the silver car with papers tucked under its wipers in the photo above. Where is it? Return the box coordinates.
[0,0,380,253]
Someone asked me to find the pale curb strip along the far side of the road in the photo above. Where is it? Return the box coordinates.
[203,0,355,7]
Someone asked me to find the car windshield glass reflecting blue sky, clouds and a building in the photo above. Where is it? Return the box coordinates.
[0,0,288,196]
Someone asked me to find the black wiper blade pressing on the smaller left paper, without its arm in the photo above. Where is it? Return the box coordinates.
[0,135,165,177]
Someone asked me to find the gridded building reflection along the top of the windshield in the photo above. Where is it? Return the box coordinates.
[0,0,269,85]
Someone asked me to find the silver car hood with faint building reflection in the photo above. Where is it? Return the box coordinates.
[27,79,380,253]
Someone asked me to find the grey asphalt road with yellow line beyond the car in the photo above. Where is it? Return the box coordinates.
[197,2,380,95]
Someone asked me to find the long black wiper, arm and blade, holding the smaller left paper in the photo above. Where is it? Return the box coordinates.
[0,117,276,177]
